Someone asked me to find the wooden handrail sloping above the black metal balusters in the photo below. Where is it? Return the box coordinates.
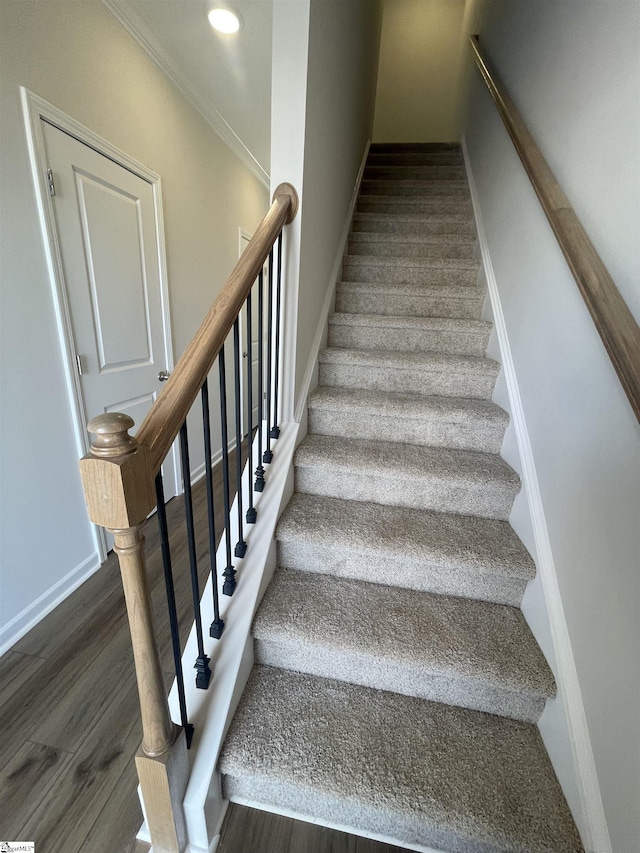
[136,184,298,474]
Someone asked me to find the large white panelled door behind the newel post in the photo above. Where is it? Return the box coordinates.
[42,120,176,499]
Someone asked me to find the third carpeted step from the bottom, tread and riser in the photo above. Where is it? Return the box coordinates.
[276,493,535,588]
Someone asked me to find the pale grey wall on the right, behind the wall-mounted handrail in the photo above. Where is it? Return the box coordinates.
[466,0,640,853]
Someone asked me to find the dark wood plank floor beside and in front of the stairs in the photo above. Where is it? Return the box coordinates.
[0,442,402,853]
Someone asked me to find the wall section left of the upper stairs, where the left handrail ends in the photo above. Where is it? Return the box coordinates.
[271,0,380,411]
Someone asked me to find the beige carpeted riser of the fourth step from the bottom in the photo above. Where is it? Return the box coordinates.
[295,458,516,521]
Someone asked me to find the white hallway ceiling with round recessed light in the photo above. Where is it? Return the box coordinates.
[103,0,273,185]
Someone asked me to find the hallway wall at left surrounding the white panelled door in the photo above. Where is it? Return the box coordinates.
[0,0,268,646]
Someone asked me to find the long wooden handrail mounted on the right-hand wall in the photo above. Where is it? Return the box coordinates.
[469,35,640,421]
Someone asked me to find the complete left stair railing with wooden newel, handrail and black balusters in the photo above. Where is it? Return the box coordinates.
[80,184,298,853]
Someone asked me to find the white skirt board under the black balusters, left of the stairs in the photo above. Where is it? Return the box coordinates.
[138,422,299,853]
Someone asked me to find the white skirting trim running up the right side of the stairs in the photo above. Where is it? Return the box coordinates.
[462,138,612,853]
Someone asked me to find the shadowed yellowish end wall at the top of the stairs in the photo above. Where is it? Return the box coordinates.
[373,0,465,142]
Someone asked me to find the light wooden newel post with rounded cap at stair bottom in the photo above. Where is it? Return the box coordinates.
[80,413,189,853]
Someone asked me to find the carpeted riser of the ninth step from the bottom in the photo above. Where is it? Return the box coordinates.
[342,256,478,285]
